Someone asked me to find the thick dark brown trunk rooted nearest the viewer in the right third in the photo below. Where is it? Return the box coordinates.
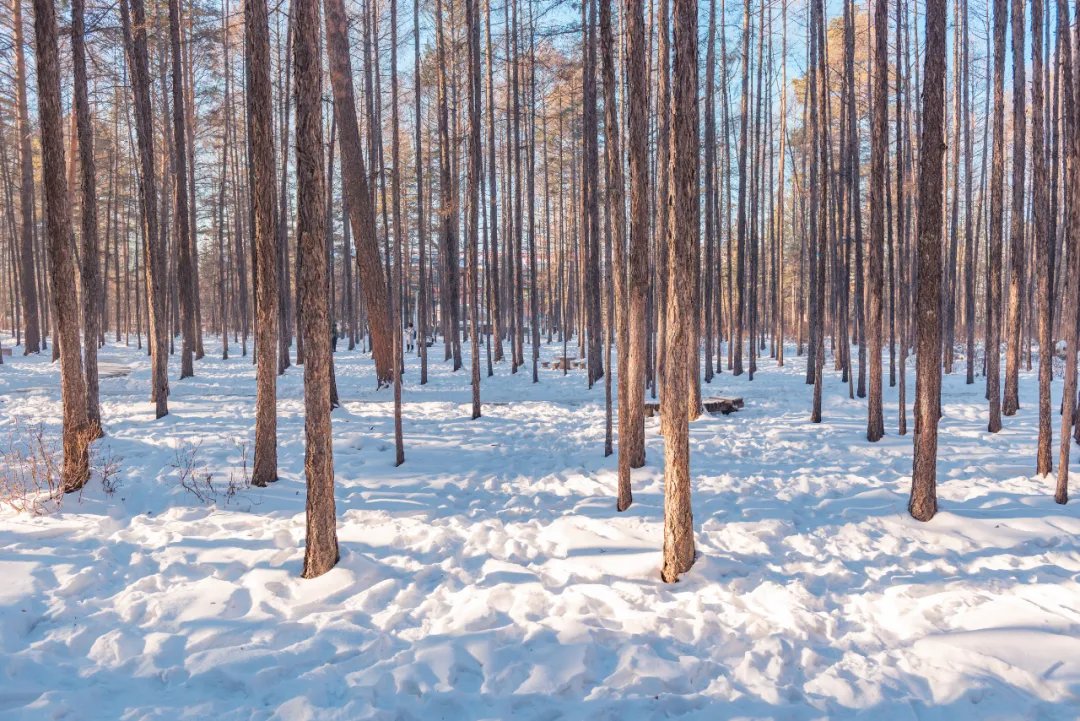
[908,0,945,521]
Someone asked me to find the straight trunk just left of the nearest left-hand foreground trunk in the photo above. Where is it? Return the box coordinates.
[244,0,279,486]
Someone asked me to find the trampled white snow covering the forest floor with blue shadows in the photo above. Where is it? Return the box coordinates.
[0,339,1080,721]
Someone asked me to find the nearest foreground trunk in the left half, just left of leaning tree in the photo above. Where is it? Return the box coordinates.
[293,0,339,579]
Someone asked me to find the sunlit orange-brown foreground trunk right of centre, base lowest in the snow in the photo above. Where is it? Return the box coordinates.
[660,0,699,583]
